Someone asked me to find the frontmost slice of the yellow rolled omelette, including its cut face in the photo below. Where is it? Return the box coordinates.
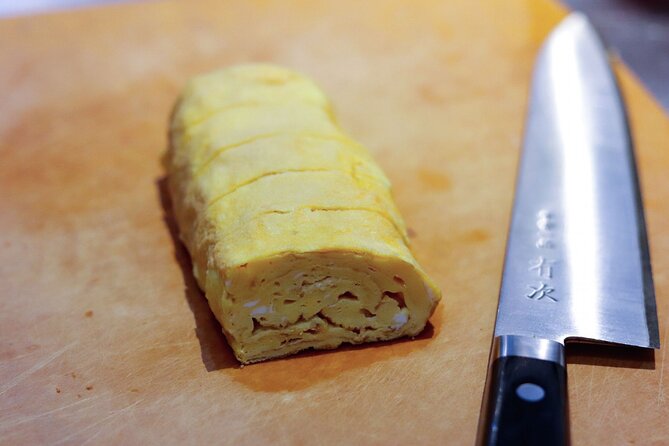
[195,208,440,363]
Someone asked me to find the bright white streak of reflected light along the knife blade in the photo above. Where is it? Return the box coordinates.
[549,23,604,338]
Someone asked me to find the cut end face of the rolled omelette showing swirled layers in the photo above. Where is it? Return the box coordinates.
[206,251,438,363]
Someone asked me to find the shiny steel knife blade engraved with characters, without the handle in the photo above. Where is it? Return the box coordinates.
[495,14,659,347]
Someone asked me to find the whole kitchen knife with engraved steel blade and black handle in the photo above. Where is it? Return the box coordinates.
[478,13,660,446]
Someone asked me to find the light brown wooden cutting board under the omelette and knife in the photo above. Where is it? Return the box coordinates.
[0,0,669,445]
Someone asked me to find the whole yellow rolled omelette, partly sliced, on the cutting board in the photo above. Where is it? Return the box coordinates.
[165,64,441,363]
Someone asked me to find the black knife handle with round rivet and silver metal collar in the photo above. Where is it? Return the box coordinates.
[479,336,569,446]
